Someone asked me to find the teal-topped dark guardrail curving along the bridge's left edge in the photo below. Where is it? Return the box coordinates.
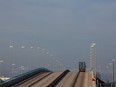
[0,68,52,87]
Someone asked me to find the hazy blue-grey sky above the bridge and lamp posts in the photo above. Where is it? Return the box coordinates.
[0,0,116,79]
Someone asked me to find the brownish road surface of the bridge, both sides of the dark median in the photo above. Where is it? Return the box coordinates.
[12,72,95,87]
